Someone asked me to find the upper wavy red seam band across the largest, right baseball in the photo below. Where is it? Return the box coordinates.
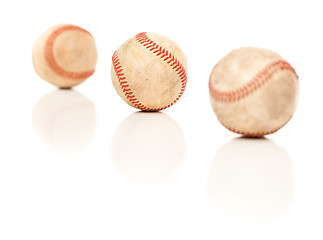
[209,60,298,102]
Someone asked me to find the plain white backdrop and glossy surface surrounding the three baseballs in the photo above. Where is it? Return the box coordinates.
[0,0,323,240]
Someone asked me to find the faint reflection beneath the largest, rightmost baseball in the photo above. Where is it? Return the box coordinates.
[208,138,295,222]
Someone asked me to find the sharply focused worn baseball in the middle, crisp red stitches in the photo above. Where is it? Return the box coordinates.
[111,33,187,111]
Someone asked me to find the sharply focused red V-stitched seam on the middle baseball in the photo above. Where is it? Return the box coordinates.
[112,32,187,111]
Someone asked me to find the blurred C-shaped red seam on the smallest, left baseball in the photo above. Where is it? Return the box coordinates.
[44,25,94,80]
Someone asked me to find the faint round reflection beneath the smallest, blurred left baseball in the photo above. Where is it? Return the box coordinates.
[32,89,96,153]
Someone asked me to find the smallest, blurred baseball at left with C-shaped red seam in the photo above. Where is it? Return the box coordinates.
[33,24,97,88]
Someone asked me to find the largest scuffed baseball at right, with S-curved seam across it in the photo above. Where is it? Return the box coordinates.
[209,47,298,137]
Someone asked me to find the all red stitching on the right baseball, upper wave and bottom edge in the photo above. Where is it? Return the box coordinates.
[209,60,298,137]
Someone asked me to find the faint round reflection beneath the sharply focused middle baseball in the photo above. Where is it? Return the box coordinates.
[111,112,185,185]
